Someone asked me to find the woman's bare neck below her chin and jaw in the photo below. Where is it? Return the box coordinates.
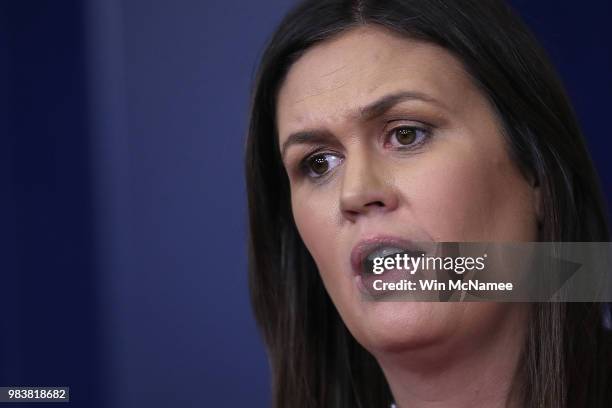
[375,304,528,408]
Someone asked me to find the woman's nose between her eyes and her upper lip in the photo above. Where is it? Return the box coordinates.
[340,157,399,222]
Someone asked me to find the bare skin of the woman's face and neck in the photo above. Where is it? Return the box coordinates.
[277,26,539,407]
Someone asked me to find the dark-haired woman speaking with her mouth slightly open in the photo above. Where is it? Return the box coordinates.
[246,0,612,408]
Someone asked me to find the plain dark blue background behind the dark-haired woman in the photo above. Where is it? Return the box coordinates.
[0,0,612,407]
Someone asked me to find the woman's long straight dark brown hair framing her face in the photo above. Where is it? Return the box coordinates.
[246,0,612,408]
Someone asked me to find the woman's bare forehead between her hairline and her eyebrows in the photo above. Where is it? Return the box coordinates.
[277,26,474,139]
